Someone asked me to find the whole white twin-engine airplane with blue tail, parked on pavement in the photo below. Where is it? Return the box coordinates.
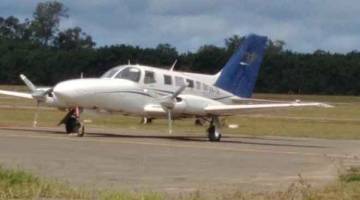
[0,34,329,141]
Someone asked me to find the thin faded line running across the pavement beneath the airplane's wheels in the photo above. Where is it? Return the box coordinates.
[0,130,360,161]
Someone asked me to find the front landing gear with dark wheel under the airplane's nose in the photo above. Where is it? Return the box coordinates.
[58,108,85,137]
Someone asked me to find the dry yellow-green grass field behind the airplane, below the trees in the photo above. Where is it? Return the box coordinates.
[0,86,360,139]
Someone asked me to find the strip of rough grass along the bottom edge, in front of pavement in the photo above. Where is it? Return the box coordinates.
[0,167,360,200]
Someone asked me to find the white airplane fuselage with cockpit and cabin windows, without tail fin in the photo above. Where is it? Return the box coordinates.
[45,65,234,117]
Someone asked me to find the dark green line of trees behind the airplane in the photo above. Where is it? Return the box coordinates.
[0,1,360,95]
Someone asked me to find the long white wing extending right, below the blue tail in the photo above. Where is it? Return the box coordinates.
[204,102,332,115]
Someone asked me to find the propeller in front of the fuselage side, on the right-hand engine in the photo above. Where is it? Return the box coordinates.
[160,84,188,134]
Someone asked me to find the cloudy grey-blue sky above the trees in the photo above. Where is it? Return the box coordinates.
[0,0,360,53]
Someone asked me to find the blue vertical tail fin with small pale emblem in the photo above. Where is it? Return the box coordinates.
[215,34,267,98]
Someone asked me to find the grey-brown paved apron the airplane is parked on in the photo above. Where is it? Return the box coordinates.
[0,126,360,192]
